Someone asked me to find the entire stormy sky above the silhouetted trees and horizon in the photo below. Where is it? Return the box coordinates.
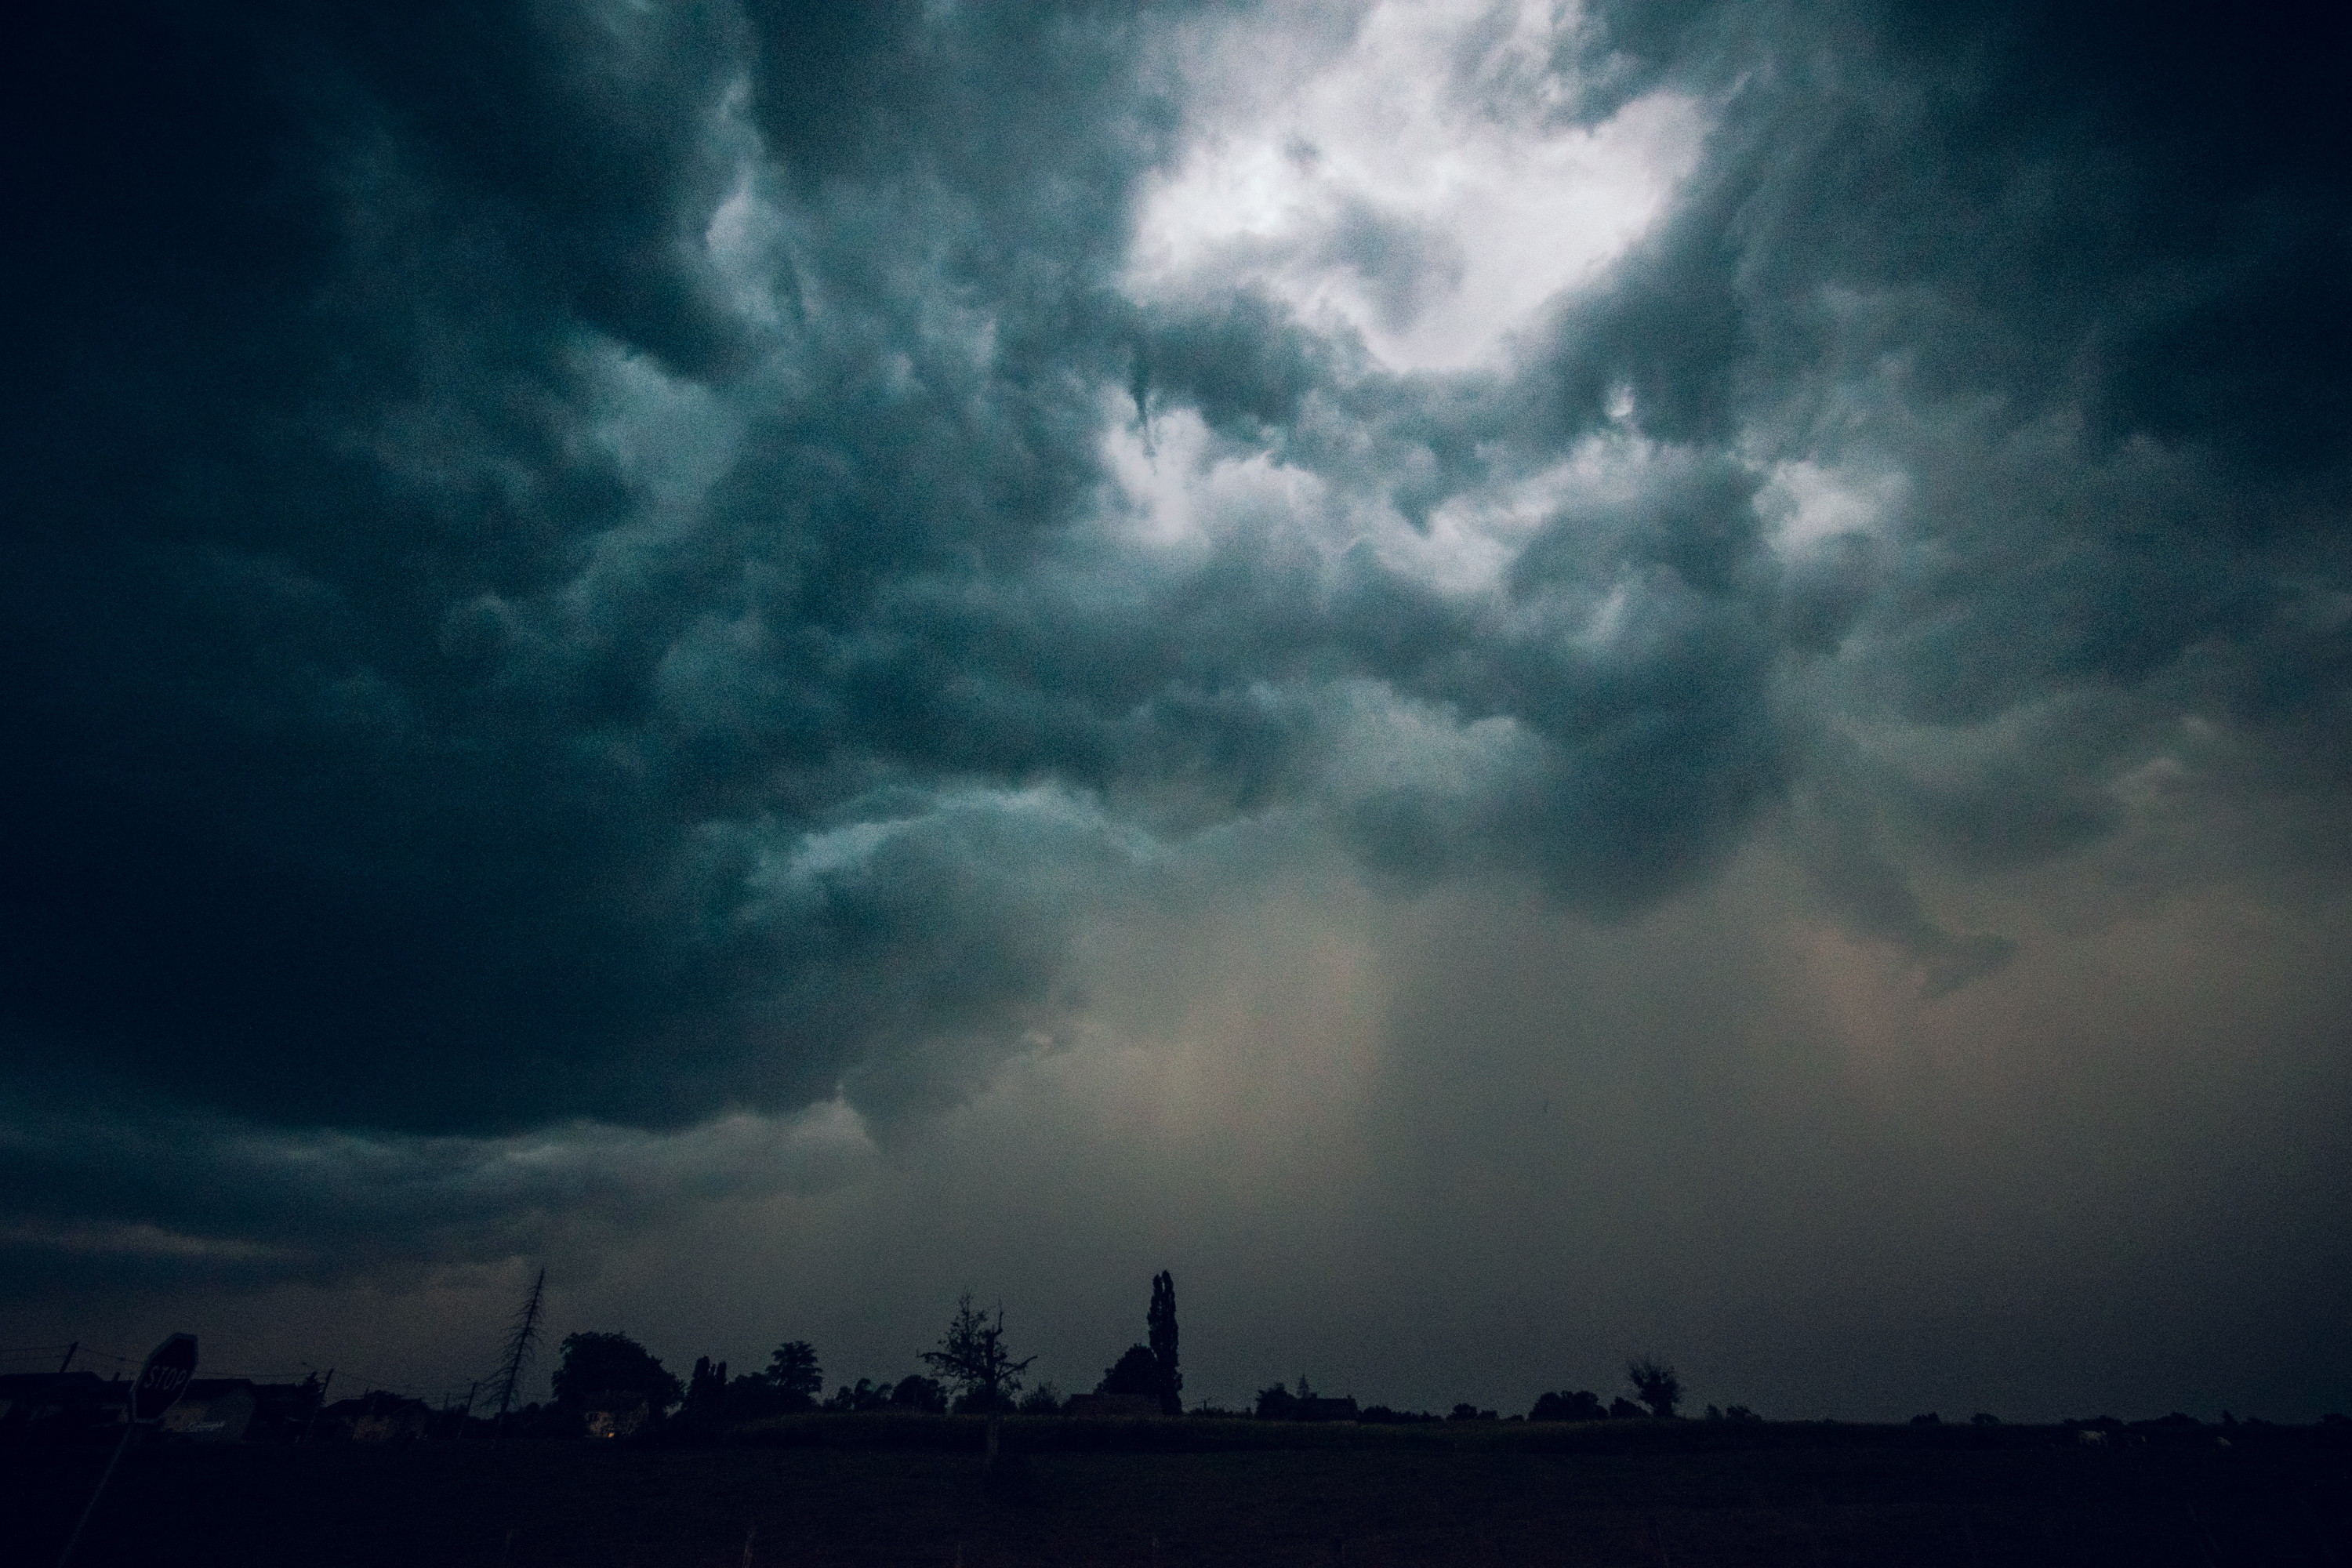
[0,0,2352,1420]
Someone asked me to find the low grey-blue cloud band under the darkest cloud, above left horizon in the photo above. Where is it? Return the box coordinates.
[0,1102,873,1295]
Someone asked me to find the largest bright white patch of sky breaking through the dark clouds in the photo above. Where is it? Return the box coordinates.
[1129,0,1708,372]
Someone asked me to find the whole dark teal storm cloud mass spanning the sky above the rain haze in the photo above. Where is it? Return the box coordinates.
[0,5,2352,1288]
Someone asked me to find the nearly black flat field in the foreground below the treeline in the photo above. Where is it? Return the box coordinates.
[0,1417,2352,1568]
